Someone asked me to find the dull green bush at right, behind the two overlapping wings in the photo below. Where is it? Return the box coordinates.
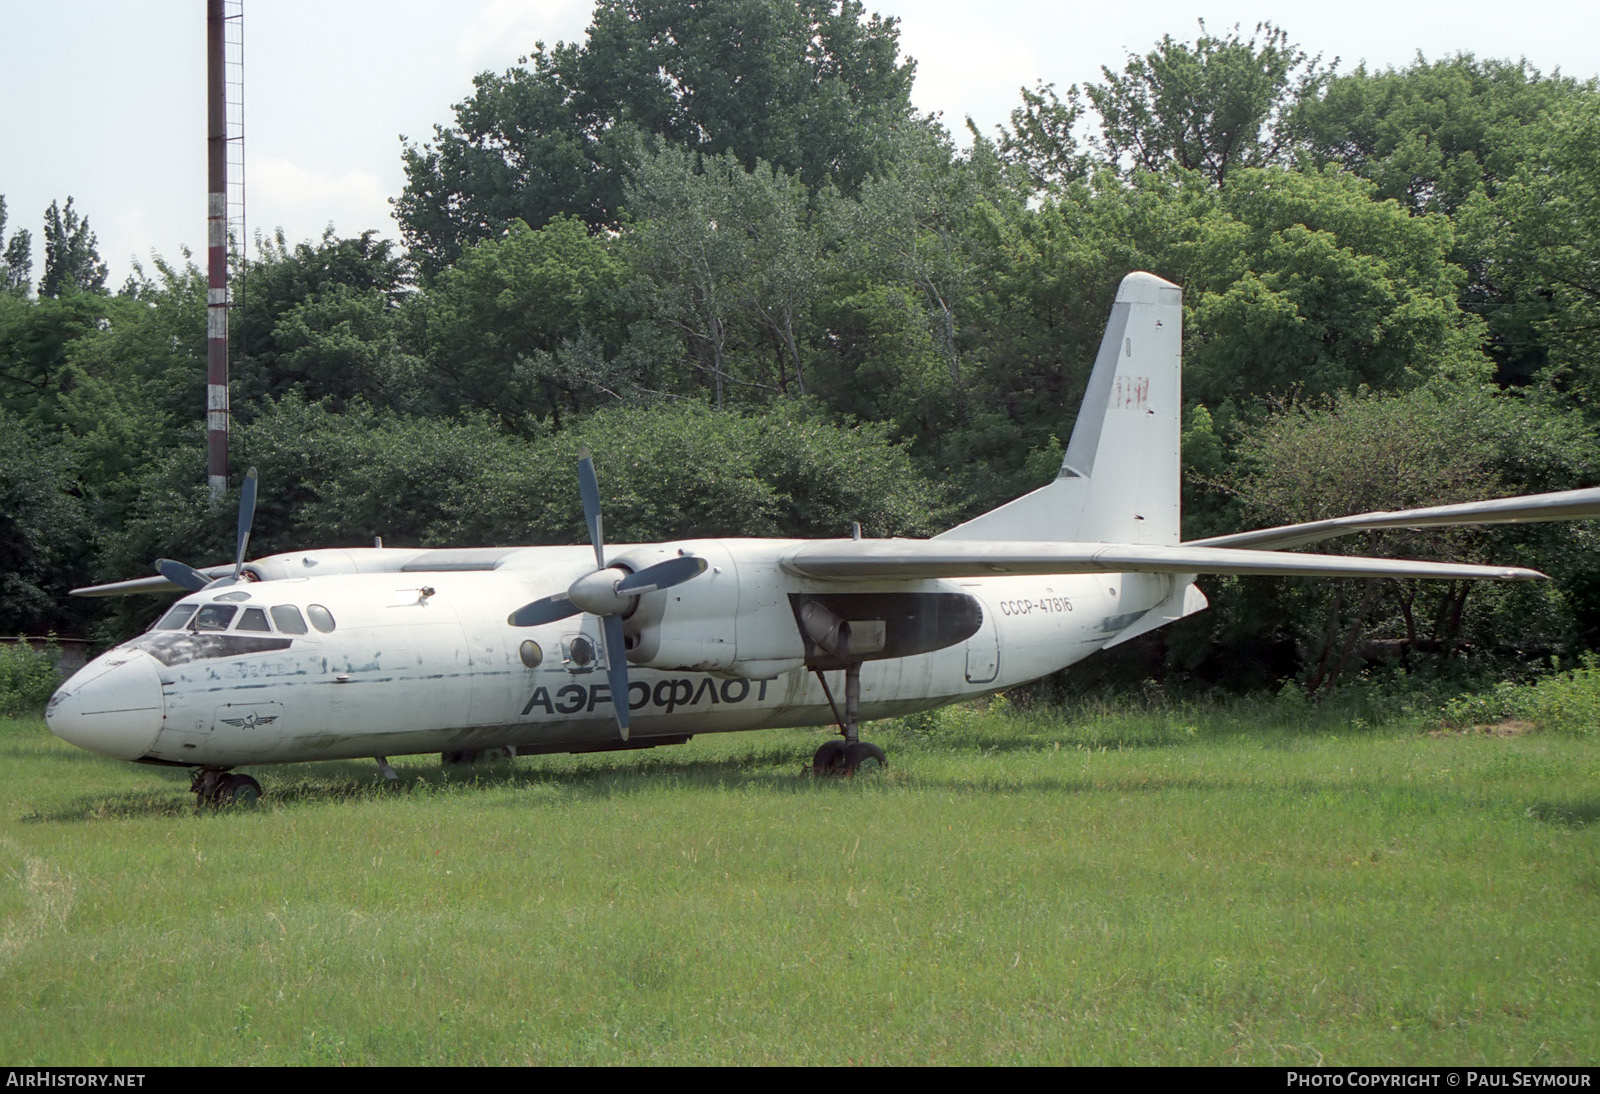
[1227,385,1600,693]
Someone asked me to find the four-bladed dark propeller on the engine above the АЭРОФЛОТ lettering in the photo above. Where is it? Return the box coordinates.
[506,448,706,741]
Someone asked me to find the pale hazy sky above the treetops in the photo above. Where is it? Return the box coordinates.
[0,0,1600,288]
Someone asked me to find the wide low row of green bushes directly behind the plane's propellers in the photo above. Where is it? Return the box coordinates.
[96,395,947,614]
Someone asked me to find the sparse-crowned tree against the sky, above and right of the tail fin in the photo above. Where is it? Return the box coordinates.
[1085,21,1331,186]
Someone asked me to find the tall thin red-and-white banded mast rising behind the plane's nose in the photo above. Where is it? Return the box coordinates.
[205,0,229,502]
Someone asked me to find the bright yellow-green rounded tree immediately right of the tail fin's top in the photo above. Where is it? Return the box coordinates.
[1138,166,1490,408]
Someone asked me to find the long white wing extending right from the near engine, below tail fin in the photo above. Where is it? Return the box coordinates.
[779,539,1546,581]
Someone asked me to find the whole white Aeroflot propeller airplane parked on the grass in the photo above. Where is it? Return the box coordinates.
[46,274,1600,803]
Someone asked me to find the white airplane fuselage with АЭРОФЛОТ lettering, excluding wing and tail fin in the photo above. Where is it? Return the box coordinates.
[46,539,1178,768]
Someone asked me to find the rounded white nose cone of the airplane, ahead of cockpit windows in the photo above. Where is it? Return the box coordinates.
[45,649,163,760]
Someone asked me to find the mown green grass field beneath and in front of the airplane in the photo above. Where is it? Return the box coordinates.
[0,702,1600,1065]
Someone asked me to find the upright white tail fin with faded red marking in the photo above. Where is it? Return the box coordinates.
[936,274,1184,545]
